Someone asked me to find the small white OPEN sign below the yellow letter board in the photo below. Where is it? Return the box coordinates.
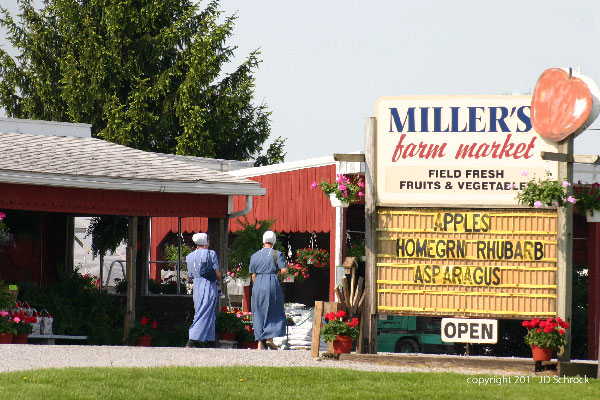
[442,318,498,343]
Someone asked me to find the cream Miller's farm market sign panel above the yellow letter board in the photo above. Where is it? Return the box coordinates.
[375,96,557,207]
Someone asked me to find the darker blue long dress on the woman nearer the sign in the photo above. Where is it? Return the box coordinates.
[250,248,286,340]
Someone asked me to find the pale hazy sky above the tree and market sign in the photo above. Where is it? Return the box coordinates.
[0,0,600,161]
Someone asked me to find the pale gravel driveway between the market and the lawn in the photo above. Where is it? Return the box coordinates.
[0,344,506,374]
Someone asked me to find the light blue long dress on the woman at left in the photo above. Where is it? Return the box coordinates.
[185,249,219,342]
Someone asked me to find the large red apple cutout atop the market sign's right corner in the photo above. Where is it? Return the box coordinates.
[531,68,600,142]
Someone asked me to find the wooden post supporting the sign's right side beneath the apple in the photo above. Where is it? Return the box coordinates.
[556,136,573,362]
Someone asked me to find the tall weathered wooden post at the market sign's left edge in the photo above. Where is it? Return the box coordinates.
[360,117,377,353]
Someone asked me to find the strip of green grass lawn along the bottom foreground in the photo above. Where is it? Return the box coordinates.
[0,367,600,400]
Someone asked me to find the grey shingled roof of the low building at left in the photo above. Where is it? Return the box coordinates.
[0,133,266,195]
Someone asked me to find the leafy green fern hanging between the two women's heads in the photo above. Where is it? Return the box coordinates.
[229,217,284,278]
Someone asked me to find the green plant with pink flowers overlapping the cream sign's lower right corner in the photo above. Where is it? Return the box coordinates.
[511,171,577,208]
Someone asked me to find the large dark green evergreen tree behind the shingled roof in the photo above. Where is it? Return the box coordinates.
[0,0,285,165]
